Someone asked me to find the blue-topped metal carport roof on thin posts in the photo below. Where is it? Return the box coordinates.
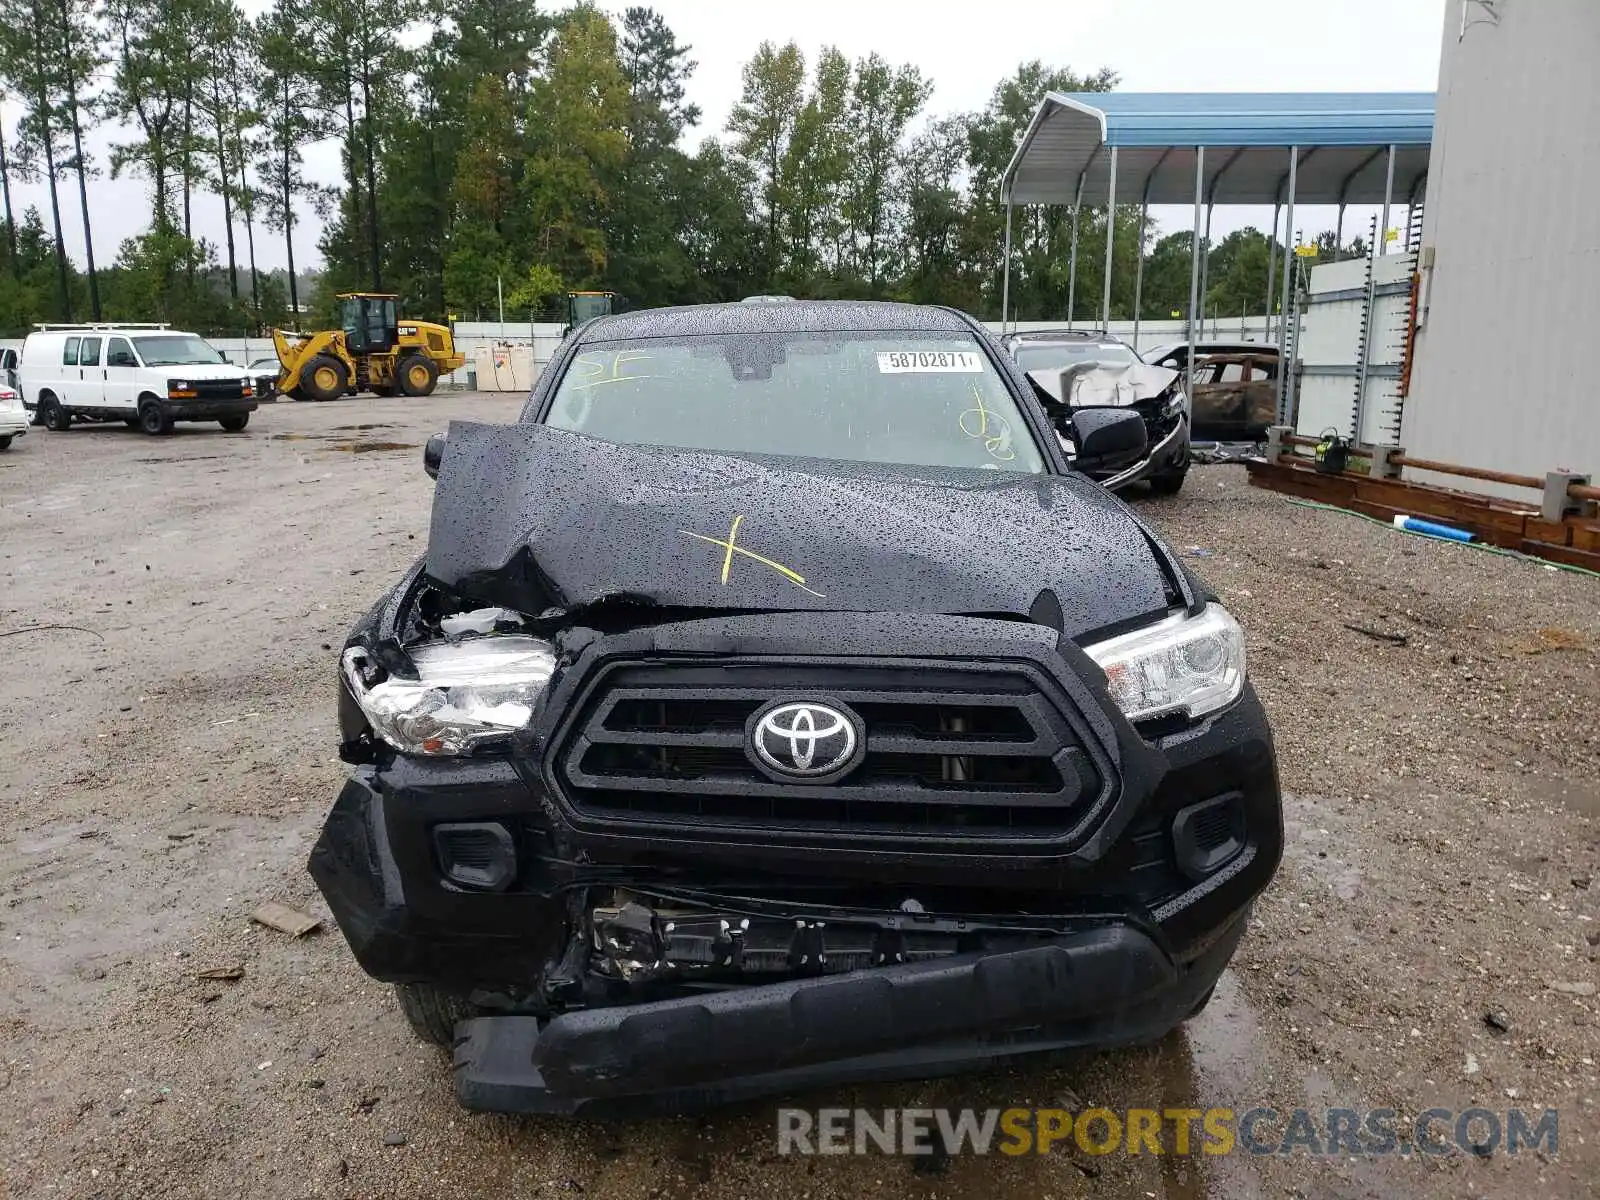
[1005,91,1434,205]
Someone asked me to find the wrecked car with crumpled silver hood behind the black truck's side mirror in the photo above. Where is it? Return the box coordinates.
[1003,330,1189,496]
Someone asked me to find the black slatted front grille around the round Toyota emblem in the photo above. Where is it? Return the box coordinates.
[552,659,1102,838]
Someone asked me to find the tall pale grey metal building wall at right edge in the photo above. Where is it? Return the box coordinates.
[1402,0,1600,498]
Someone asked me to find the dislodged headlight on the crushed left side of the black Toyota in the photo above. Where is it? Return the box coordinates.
[341,637,555,755]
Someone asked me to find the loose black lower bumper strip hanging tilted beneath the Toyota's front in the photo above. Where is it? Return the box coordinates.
[454,914,1248,1115]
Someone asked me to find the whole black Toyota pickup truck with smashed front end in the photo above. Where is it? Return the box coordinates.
[310,302,1282,1114]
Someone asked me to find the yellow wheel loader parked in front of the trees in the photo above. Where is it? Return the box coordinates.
[272,291,467,400]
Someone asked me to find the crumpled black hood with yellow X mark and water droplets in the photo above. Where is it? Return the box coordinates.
[427,422,1168,635]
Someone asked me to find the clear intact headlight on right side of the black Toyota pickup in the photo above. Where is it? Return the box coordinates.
[1083,605,1245,720]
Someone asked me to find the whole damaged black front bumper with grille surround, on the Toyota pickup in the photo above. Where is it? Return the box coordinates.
[310,613,1283,1112]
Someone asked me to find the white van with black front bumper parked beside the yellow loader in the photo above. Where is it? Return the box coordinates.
[18,325,256,434]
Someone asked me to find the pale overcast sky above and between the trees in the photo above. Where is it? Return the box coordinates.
[3,0,1445,267]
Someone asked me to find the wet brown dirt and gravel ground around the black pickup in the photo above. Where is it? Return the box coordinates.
[0,395,1600,1200]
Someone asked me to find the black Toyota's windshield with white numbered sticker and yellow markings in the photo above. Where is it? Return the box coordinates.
[546,333,1045,474]
